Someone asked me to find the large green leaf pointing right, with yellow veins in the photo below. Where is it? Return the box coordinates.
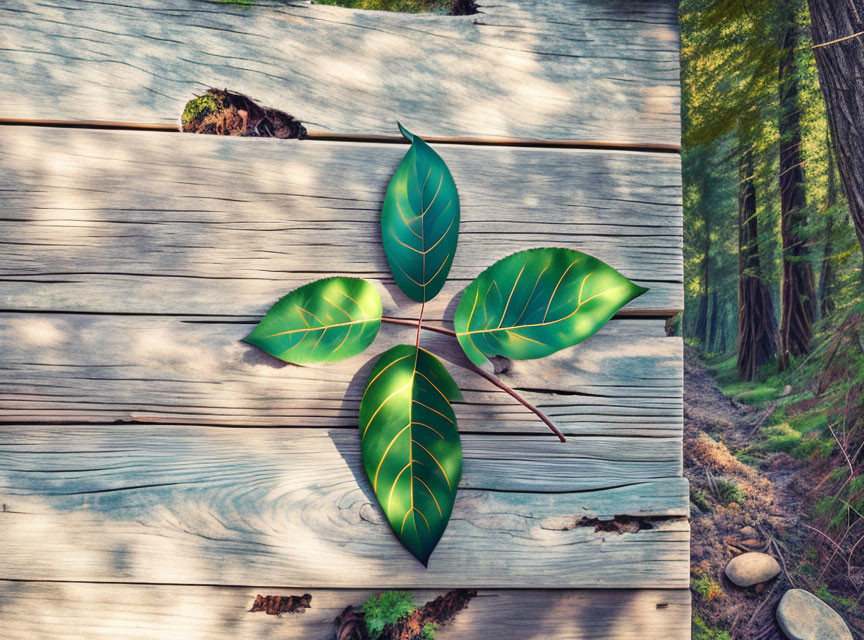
[453,248,647,365]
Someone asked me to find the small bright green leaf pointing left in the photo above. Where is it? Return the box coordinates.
[245,278,381,364]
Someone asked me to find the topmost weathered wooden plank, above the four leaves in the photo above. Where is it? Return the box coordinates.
[0,0,680,145]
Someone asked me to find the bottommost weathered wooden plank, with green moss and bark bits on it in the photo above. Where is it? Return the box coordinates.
[0,581,690,640]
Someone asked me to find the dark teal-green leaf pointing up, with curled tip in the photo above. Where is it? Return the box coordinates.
[381,124,459,302]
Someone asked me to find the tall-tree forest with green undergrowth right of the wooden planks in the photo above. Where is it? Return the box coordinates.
[670,0,864,640]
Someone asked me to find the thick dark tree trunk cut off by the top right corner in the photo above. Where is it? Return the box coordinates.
[808,0,864,251]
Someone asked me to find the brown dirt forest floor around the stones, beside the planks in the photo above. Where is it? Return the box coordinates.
[684,347,864,640]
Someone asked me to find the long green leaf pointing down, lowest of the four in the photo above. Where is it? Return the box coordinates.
[360,345,462,565]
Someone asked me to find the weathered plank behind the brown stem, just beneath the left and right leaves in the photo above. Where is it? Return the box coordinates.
[0,313,682,437]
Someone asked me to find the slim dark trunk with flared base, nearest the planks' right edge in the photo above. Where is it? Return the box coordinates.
[737,145,777,380]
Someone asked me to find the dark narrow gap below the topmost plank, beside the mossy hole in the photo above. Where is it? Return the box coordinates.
[0,118,681,154]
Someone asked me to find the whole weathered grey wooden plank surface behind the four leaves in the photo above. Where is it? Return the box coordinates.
[0,0,689,640]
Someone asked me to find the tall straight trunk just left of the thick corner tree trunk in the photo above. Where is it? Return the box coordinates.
[779,10,816,366]
